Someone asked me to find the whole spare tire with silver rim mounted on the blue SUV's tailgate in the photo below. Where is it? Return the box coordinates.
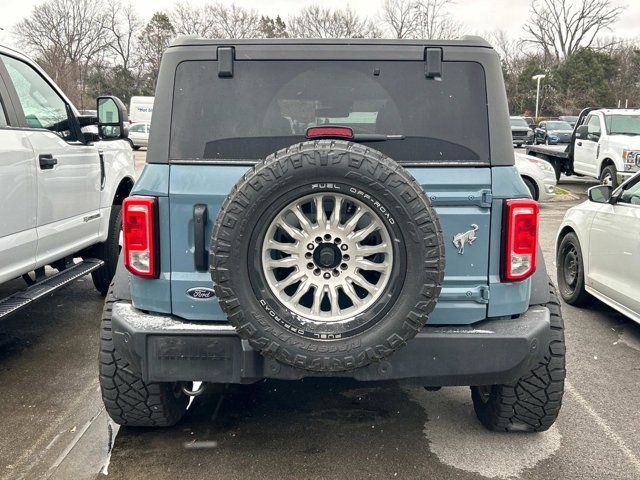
[210,140,445,372]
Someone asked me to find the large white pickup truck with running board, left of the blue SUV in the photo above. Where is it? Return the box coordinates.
[0,46,134,318]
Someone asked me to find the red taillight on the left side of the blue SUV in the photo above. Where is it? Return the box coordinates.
[122,197,158,277]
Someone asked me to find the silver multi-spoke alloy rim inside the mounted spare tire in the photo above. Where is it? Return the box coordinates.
[261,192,393,322]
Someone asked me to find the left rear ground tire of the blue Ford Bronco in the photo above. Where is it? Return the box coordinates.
[99,290,189,427]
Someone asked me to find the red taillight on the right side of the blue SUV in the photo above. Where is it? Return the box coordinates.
[502,199,540,282]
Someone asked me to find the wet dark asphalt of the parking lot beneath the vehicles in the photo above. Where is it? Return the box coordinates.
[0,162,640,480]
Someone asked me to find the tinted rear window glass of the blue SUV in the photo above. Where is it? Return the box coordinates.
[170,61,489,163]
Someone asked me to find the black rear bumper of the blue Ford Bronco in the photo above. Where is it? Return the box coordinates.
[112,302,550,386]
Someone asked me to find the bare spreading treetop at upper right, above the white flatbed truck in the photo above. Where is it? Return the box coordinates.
[524,0,624,62]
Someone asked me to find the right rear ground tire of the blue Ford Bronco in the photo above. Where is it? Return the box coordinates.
[471,282,566,432]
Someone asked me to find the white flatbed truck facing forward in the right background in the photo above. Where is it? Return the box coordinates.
[526,108,640,188]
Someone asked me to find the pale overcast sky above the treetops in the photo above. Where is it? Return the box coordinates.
[0,0,640,44]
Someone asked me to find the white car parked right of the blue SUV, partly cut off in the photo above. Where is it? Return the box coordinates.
[556,173,640,322]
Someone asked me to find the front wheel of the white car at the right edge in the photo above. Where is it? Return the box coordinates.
[556,232,591,307]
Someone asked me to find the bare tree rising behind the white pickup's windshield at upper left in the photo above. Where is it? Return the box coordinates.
[14,0,110,108]
